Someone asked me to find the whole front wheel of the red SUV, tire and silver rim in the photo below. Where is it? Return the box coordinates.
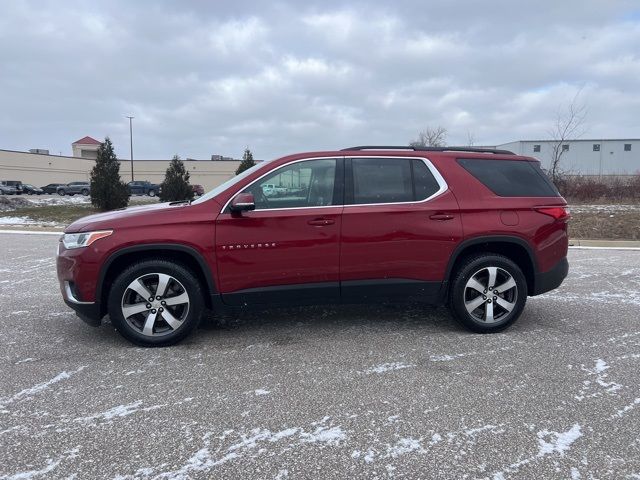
[107,259,204,347]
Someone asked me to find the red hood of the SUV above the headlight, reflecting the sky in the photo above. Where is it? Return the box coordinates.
[64,202,191,233]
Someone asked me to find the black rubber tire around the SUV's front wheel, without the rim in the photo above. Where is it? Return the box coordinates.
[107,259,204,347]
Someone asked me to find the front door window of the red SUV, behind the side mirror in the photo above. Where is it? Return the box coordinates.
[244,159,336,210]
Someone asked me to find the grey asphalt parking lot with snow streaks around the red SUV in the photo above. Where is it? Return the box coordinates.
[0,234,640,479]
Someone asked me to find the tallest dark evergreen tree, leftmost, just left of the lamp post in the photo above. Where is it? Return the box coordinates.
[91,137,129,210]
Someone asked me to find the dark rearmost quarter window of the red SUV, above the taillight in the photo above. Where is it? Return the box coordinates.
[458,158,560,197]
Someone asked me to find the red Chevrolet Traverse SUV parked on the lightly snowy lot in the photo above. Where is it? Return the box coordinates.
[57,147,569,346]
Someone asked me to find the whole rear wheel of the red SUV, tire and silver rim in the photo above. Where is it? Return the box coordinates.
[449,253,527,333]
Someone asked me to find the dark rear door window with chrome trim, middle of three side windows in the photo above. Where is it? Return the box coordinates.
[351,158,440,204]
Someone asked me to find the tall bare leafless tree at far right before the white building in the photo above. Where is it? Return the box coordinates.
[549,89,587,182]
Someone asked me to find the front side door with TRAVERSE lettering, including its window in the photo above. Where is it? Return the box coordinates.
[216,158,344,305]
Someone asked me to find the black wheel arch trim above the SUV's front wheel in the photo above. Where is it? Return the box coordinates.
[96,243,217,314]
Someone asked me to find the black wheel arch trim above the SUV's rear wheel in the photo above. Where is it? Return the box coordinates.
[445,235,538,294]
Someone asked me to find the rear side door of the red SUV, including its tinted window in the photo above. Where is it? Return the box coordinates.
[340,157,462,301]
